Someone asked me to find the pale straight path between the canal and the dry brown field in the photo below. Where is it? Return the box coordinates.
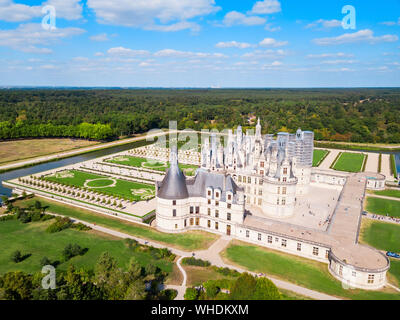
[0,130,177,171]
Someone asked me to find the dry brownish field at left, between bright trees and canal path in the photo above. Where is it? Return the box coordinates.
[0,139,98,164]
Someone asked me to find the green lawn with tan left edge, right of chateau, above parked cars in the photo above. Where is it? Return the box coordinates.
[360,219,400,253]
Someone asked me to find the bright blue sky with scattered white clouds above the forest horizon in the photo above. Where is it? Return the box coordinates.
[0,0,400,88]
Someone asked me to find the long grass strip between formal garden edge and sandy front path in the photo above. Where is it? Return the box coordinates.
[16,198,218,251]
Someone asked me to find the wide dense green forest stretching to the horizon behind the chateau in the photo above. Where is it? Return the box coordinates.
[0,88,400,143]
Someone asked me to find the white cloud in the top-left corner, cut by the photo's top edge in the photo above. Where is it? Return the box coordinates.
[0,0,82,22]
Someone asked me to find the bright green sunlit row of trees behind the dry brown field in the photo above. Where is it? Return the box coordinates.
[0,120,116,140]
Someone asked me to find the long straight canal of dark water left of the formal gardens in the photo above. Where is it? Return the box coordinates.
[0,140,152,203]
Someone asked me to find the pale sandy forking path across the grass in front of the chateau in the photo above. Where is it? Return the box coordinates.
[48,212,340,300]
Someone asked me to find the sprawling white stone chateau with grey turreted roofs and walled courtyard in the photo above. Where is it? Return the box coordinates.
[156,122,390,290]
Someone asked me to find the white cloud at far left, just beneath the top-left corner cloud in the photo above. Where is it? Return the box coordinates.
[0,23,85,53]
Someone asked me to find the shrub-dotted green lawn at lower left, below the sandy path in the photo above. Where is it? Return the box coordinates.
[0,220,172,274]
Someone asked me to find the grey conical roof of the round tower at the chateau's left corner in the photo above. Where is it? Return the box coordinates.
[157,149,189,200]
